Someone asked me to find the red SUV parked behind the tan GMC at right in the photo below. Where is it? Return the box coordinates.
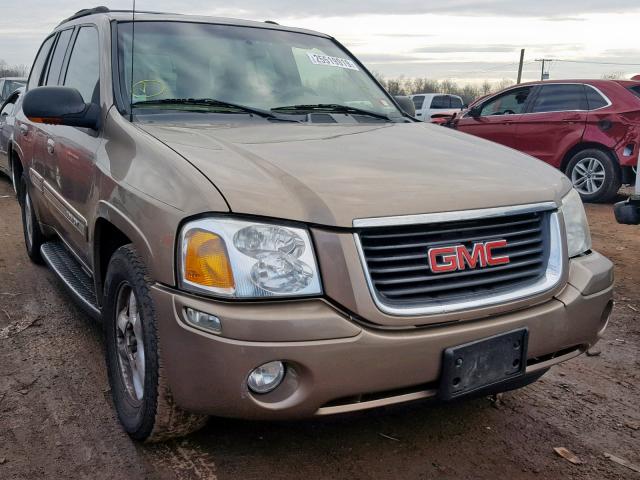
[453,80,640,202]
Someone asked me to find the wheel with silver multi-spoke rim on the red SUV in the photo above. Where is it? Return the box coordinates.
[566,148,622,203]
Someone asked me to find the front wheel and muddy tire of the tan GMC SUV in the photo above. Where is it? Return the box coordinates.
[103,245,207,442]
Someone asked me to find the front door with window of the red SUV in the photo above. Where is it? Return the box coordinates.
[457,87,533,148]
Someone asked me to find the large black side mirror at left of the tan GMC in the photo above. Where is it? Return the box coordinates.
[22,87,100,130]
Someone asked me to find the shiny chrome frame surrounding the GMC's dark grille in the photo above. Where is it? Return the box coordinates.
[353,202,566,317]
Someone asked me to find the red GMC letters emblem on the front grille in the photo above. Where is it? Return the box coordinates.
[429,240,510,273]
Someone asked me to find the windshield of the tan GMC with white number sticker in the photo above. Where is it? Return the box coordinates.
[118,21,402,117]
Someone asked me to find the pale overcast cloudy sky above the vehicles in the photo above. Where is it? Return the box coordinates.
[0,0,640,83]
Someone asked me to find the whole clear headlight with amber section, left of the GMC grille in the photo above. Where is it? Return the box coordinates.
[178,218,322,298]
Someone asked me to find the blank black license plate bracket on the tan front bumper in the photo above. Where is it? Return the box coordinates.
[438,328,529,400]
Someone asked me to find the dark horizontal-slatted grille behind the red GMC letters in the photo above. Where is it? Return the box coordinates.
[356,207,562,311]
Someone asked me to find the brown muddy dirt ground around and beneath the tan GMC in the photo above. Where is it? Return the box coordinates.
[0,177,640,480]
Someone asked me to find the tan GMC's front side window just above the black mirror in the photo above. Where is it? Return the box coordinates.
[64,27,100,103]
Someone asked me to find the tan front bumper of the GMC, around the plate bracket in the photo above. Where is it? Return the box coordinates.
[152,253,613,419]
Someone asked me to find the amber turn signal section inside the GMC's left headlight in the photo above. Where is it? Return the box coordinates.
[184,229,235,293]
